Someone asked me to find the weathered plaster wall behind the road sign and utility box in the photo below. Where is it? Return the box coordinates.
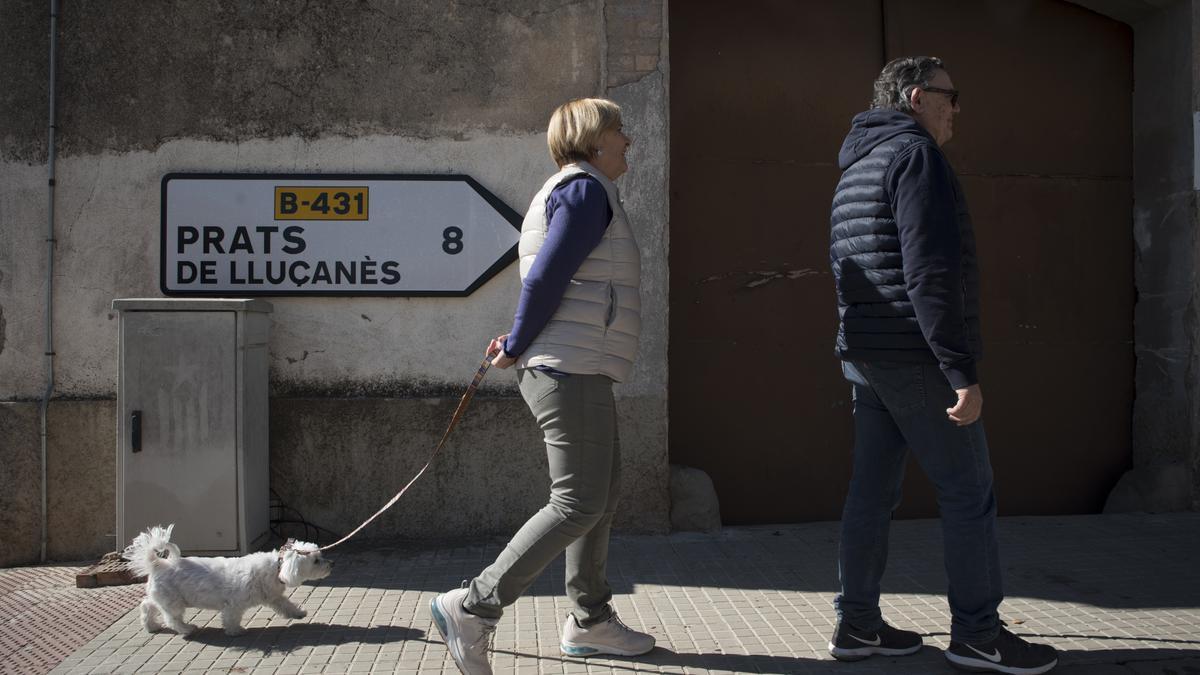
[0,0,667,565]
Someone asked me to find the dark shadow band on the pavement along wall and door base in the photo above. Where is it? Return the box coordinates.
[309,513,1200,608]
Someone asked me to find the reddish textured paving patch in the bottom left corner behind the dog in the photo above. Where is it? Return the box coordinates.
[0,567,145,675]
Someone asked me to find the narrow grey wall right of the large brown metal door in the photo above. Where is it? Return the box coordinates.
[1129,1,1200,510]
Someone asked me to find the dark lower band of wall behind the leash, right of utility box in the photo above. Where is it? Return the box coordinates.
[270,395,664,538]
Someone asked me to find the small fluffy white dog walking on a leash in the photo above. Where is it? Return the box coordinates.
[125,525,334,635]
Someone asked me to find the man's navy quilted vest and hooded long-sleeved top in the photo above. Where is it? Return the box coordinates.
[829,110,983,389]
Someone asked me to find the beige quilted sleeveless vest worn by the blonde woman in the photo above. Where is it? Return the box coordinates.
[517,162,642,382]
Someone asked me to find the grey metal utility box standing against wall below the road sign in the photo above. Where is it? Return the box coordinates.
[113,298,271,555]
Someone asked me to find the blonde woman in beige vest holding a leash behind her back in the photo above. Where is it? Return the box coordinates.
[430,98,654,675]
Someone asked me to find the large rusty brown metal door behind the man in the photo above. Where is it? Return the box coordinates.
[670,0,1133,524]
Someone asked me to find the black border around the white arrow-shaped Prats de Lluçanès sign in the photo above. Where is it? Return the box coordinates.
[158,172,524,298]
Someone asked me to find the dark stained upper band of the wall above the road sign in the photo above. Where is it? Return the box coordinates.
[0,0,604,160]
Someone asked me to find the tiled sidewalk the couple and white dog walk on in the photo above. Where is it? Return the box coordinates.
[0,513,1200,675]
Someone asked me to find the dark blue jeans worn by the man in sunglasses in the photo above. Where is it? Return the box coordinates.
[834,362,1003,643]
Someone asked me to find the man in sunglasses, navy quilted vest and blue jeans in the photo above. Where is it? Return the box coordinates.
[829,56,1058,674]
